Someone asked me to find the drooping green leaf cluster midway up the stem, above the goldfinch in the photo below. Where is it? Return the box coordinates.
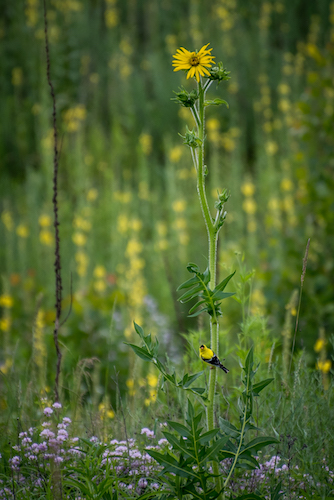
[177,263,235,321]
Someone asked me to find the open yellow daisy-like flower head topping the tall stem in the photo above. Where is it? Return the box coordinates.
[173,43,214,82]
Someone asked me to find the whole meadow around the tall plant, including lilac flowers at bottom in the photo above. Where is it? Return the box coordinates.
[0,0,334,499]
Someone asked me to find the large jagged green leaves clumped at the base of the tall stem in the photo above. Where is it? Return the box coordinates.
[138,348,280,500]
